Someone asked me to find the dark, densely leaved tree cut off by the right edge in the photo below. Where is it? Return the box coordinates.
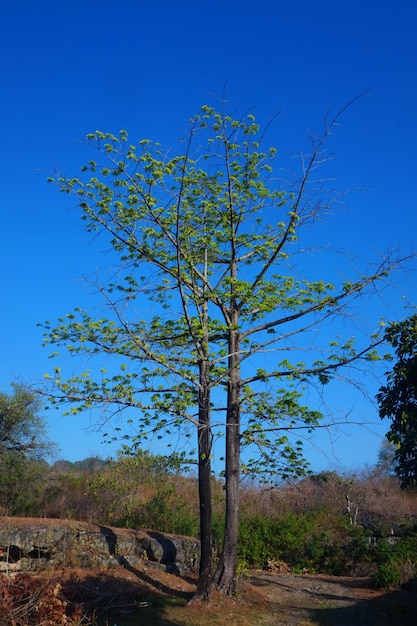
[376,315,417,487]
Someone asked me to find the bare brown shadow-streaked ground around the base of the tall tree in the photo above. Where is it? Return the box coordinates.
[39,564,417,626]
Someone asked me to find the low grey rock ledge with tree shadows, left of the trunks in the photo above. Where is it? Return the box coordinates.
[0,517,200,574]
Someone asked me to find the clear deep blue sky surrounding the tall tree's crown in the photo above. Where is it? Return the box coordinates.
[0,0,417,468]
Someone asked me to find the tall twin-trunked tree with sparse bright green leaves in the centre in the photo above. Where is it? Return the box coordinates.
[44,100,397,597]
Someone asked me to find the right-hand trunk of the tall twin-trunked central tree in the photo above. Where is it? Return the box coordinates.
[213,322,241,595]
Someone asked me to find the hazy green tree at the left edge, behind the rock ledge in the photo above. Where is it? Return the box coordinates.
[0,385,54,515]
